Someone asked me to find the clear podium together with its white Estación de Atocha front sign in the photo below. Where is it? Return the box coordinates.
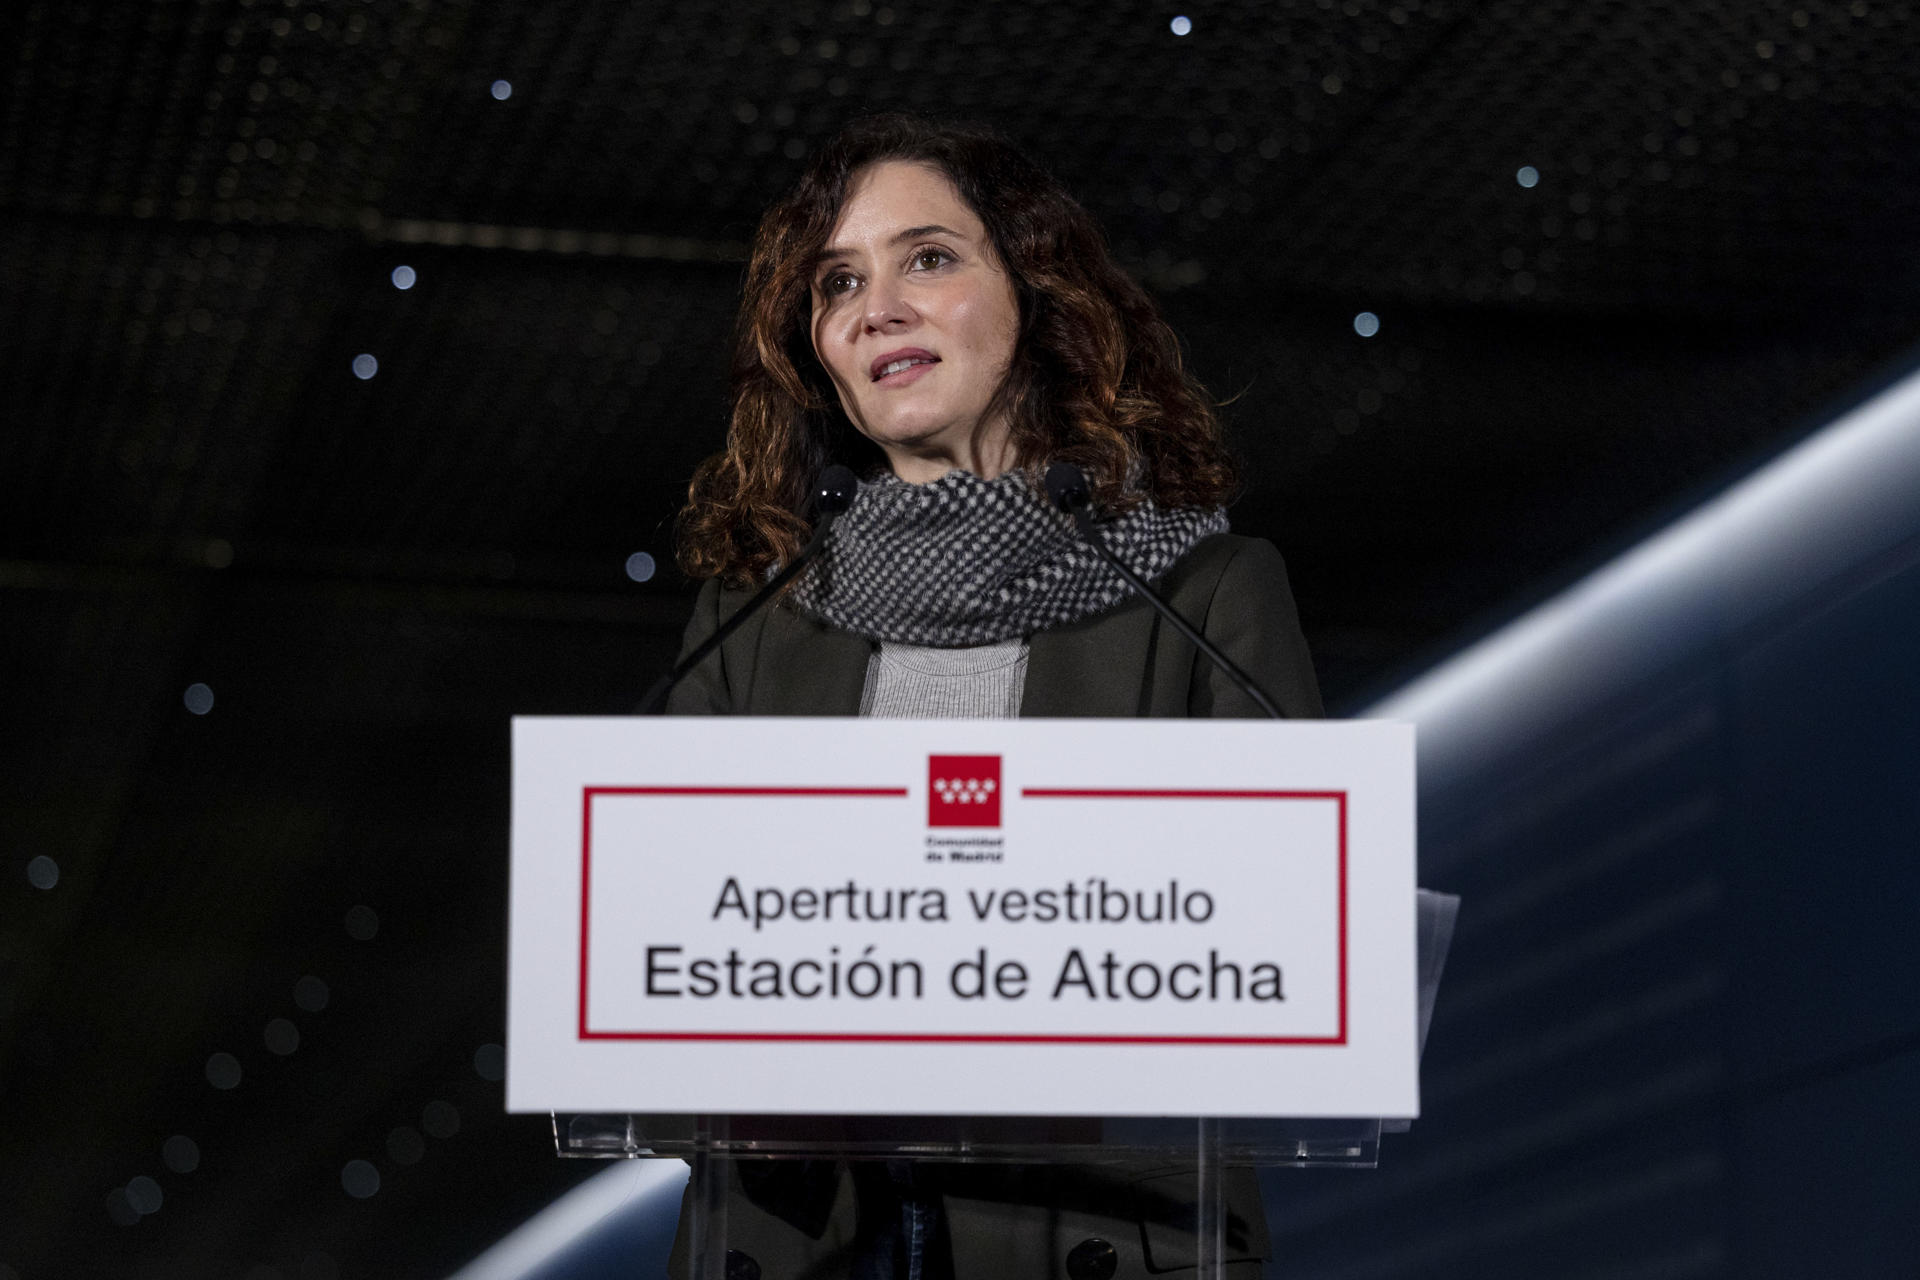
[509,720,1457,1280]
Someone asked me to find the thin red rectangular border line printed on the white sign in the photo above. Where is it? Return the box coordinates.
[578,787,1348,1046]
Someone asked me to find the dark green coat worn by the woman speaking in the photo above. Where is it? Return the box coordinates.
[666,533,1321,1280]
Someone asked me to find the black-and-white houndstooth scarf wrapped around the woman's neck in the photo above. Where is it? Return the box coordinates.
[791,470,1227,649]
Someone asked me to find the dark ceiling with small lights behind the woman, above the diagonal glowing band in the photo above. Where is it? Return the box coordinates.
[0,0,1920,1280]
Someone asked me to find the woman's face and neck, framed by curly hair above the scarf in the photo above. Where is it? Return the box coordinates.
[812,161,1020,482]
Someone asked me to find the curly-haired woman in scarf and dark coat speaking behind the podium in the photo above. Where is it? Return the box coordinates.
[668,115,1321,1280]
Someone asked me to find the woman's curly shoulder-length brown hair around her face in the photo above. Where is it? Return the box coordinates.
[680,115,1236,585]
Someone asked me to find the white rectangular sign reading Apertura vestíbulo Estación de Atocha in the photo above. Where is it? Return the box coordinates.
[507,718,1419,1117]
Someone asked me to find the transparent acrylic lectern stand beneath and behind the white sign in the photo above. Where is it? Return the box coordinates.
[553,890,1459,1280]
